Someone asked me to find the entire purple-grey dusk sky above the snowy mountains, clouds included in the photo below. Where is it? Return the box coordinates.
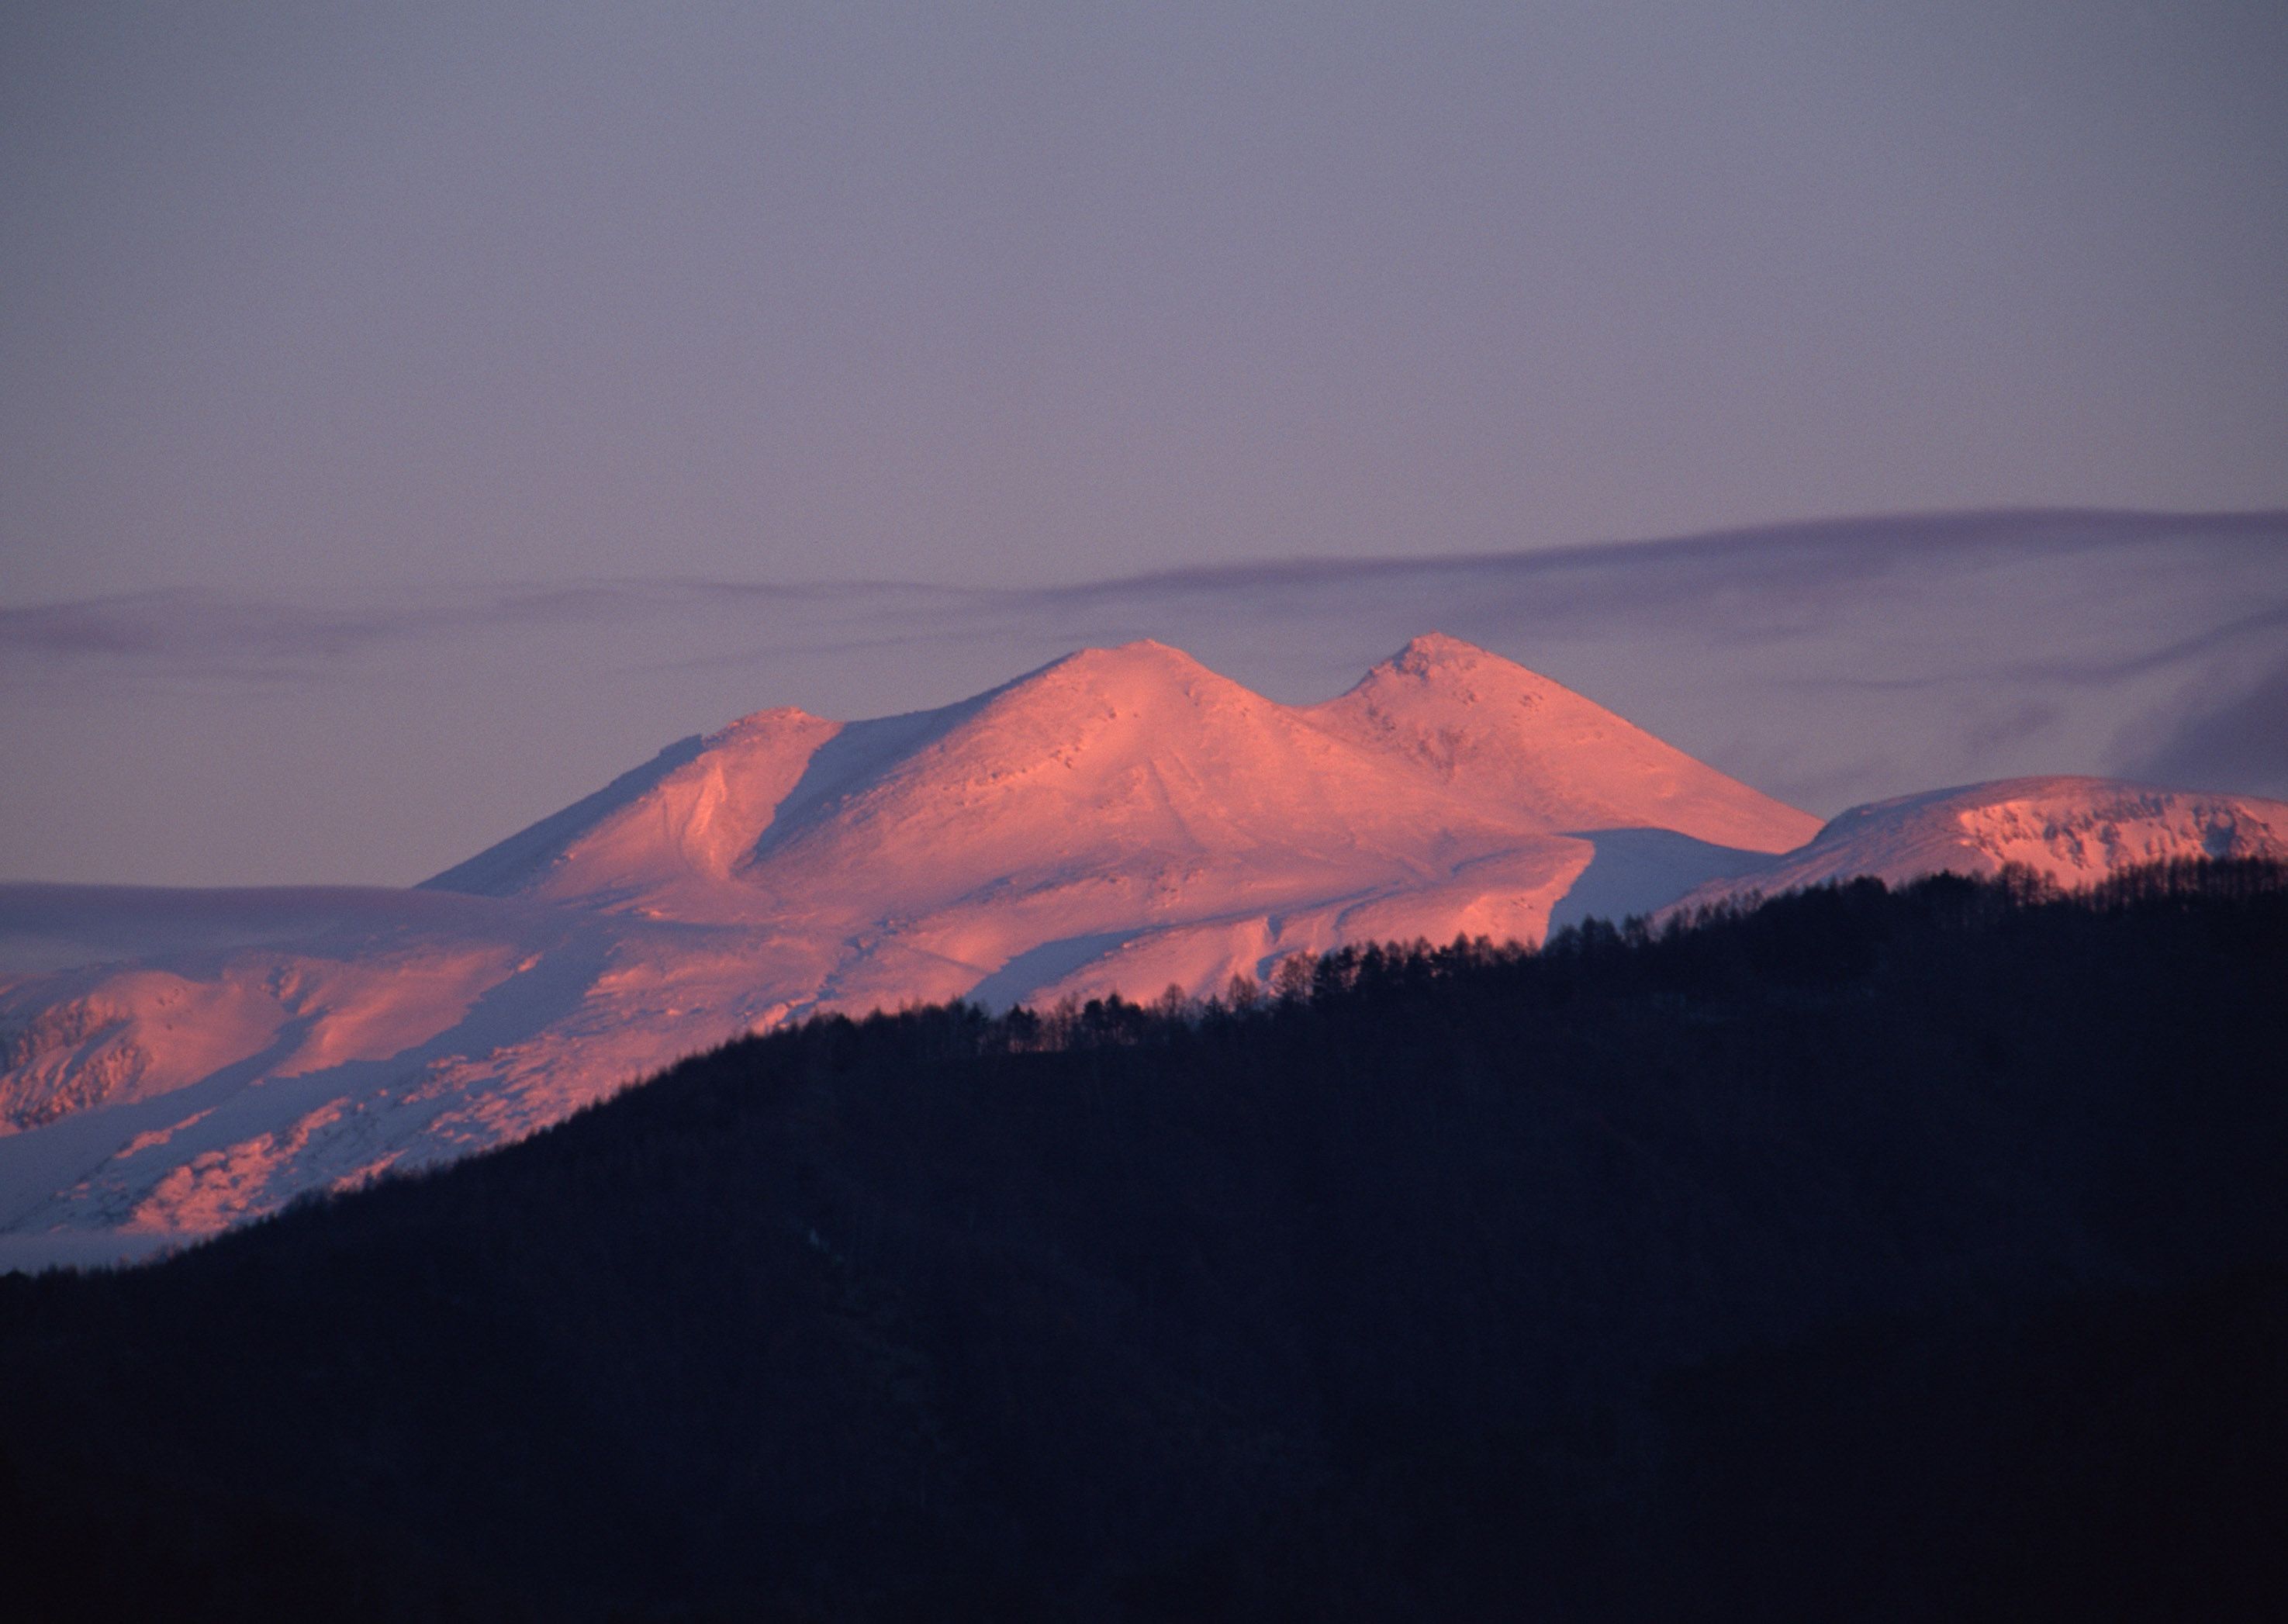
[0,0,2288,883]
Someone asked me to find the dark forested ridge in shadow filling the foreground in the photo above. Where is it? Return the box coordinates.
[0,862,2288,1619]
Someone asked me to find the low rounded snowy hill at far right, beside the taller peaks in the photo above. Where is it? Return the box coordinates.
[1672,776,2288,910]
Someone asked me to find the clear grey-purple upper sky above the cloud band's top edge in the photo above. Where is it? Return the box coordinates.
[0,0,2288,602]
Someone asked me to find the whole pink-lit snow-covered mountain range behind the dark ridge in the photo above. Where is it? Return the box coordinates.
[0,636,2288,1267]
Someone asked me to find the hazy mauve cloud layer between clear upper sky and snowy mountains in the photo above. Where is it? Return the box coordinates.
[0,513,2288,883]
